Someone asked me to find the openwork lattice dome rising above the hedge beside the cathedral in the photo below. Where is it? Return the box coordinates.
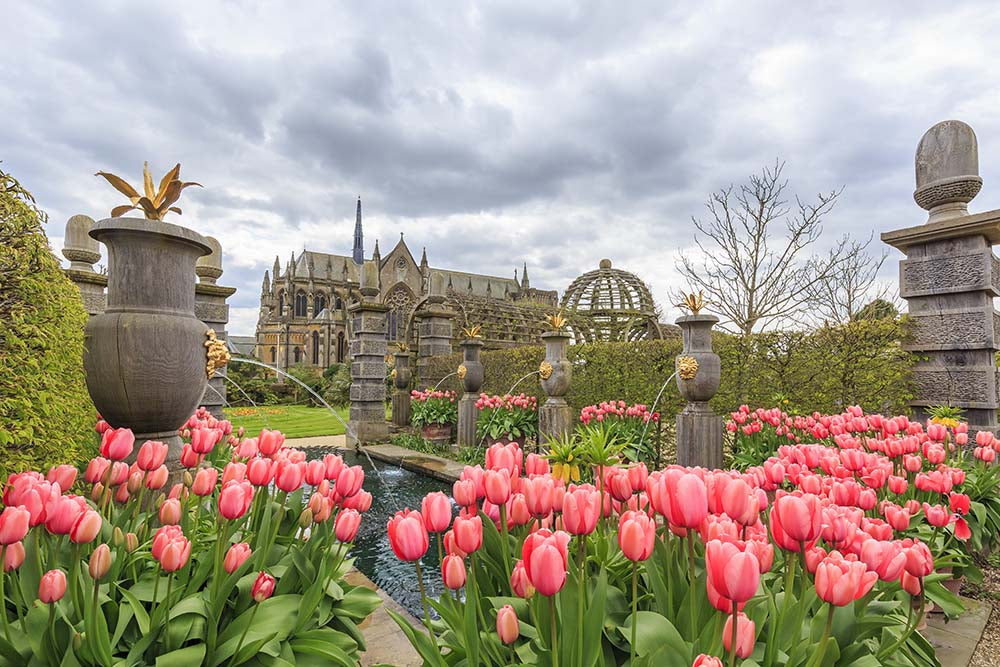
[561,259,662,343]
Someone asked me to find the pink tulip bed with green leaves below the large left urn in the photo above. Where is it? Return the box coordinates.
[0,411,378,667]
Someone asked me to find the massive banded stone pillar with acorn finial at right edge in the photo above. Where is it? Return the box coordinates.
[882,120,1000,433]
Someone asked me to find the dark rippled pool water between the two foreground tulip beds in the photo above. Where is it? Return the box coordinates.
[305,447,451,618]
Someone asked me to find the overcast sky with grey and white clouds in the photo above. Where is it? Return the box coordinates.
[0,0,1000,334]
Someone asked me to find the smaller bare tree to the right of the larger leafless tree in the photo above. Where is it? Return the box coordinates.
[807,236,895,324]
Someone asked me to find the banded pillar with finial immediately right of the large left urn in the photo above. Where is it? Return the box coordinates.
[194,236,236,419]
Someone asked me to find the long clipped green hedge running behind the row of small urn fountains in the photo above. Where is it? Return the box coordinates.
[418,319,914,420]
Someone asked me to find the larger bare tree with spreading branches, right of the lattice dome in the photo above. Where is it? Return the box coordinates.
[677,161,858,334]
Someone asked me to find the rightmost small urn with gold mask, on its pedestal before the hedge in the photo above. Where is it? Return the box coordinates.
[675,315,723,470]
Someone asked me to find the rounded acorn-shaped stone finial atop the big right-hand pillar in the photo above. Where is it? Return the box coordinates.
[913,120,983,222]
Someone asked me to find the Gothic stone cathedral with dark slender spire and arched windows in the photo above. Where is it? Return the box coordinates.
[255,198,558,368]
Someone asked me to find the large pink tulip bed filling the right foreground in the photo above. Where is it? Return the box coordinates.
[388,408,997,667]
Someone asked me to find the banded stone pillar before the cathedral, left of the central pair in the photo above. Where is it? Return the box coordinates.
[347,262,389,446]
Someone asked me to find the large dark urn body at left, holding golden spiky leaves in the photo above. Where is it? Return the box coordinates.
[83,218,212,459]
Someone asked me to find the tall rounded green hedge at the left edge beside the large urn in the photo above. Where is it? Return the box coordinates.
[0,171,94,477]
